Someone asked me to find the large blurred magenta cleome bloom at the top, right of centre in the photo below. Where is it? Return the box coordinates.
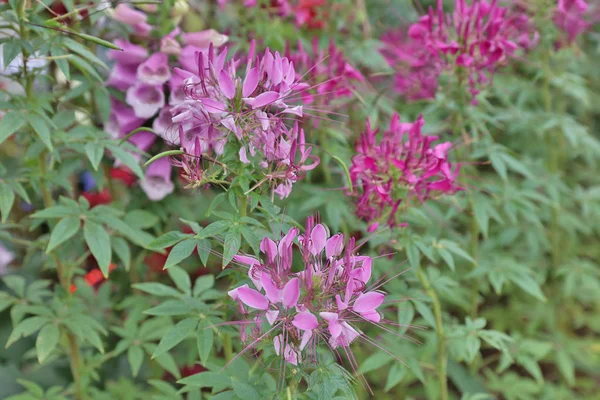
[384,0,538,102]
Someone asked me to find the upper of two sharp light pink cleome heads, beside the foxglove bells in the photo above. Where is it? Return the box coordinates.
[169,43,319,198]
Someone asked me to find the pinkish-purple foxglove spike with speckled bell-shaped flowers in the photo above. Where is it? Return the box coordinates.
[105,4,228,201]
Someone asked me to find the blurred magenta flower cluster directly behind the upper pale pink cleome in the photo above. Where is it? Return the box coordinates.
[286,38,364,112]
